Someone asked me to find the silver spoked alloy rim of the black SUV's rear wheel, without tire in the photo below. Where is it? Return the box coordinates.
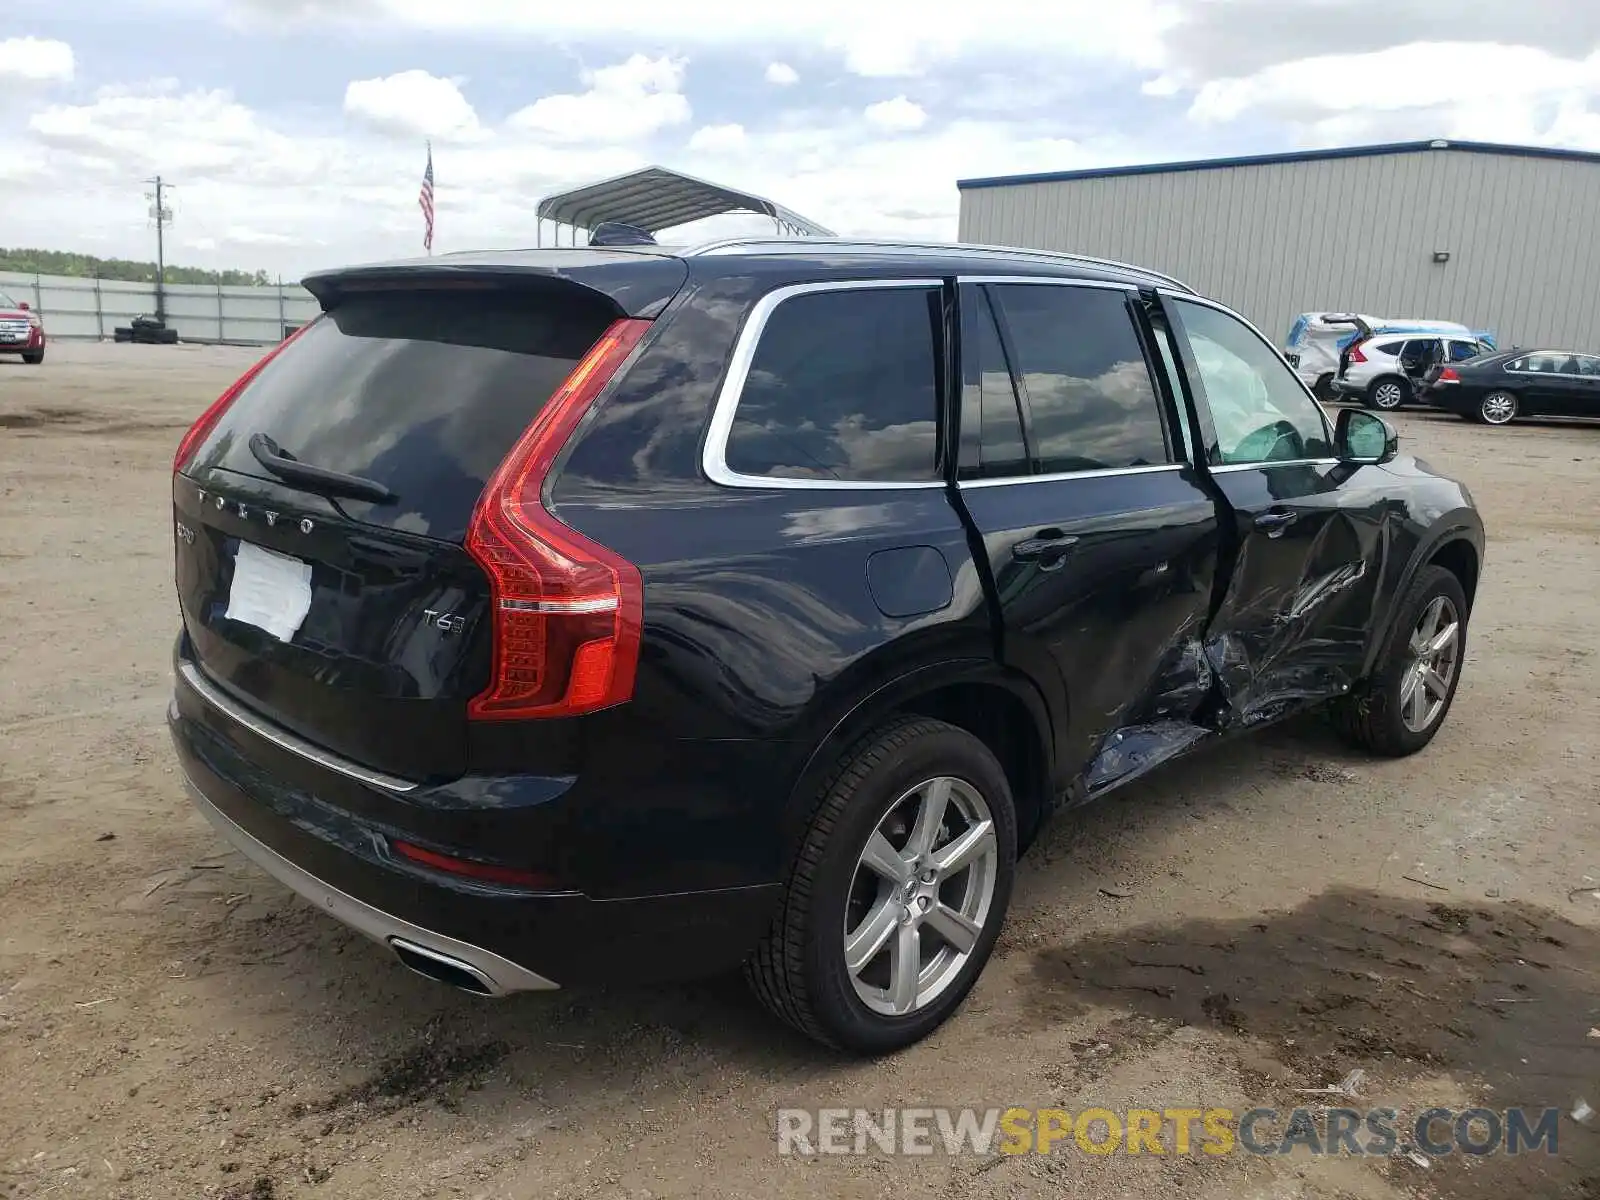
[845,776,1000,1016]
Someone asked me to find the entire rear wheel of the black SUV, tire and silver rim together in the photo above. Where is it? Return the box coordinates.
[746,717,1016,1054]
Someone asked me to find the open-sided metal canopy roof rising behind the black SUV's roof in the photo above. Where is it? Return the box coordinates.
[538,166,834,245]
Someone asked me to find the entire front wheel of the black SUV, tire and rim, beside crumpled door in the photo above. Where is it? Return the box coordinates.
[1334,566,1467,758]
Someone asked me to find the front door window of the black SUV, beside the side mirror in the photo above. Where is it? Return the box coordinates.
[1166,298,1333,464]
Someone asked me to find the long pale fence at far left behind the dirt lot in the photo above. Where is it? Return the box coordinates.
[0,270,320,346]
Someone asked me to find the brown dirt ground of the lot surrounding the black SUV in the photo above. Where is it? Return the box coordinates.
[0,344,1600,1200]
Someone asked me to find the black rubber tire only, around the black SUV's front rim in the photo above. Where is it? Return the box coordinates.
[1334,566,1470,758]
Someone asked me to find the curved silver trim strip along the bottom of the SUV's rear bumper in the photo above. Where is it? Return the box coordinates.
[184,779,560,995]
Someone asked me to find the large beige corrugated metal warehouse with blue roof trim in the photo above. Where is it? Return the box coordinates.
[957,141,1600,350]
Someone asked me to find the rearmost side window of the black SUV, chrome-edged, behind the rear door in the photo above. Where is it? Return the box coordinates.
[726,286,939,483]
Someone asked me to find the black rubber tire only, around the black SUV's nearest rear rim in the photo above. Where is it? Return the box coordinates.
[746,717,1016,1054]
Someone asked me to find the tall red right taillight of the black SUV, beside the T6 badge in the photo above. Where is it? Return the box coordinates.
[467,320,650,720]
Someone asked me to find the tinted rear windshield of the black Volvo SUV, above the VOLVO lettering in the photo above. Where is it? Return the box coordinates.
[187,290,613,541]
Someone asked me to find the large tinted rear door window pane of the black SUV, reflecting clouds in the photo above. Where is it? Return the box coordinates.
[990,283,1171,474]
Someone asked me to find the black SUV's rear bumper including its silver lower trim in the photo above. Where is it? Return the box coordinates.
[168,662,778,995]
